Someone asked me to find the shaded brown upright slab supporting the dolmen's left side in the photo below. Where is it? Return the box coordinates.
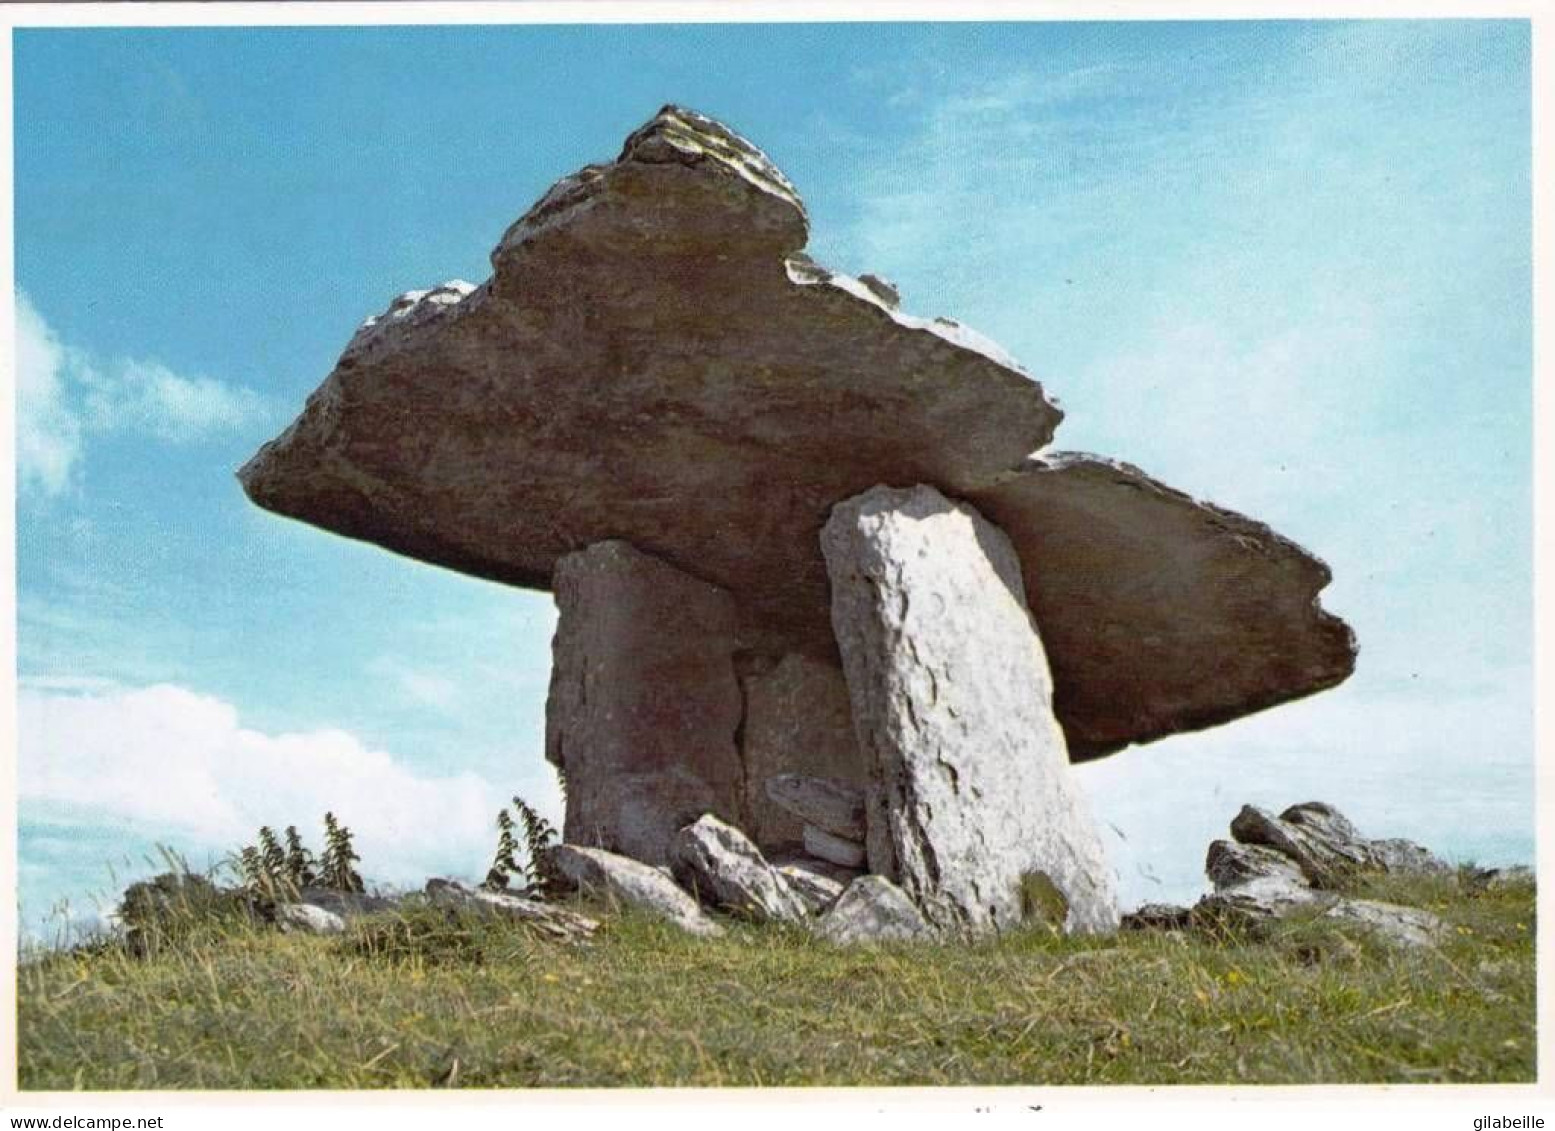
[546,541,745,863]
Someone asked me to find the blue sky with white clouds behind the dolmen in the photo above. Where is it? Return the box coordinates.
[14,22,1533,939]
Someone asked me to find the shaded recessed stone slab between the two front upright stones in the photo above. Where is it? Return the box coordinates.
[740,652,868,849]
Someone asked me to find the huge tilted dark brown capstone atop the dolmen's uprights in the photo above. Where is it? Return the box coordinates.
[239,107,1354,762]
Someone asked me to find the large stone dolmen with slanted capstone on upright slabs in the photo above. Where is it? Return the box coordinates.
[238,106,1356,935]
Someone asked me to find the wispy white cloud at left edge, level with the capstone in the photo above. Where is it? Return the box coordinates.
[16,292,263,498]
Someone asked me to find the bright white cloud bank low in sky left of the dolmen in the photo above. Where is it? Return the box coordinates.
[17,685,561,885]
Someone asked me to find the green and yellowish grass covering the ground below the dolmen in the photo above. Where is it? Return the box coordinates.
[19,877,1535,1089]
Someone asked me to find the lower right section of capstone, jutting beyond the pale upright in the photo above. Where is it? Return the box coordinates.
[967,453,1356,761]
